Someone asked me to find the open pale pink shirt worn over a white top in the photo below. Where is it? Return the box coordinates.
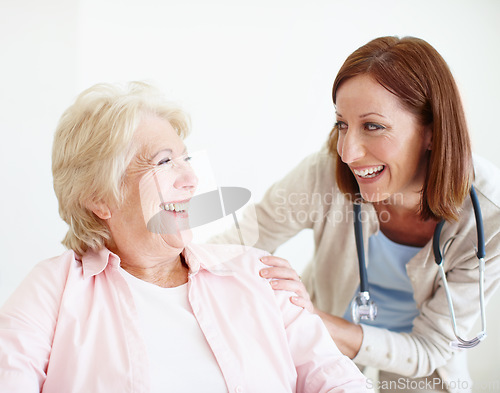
[0,245,370,393]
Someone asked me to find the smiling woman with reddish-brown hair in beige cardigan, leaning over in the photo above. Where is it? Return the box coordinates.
[216,37,500,392]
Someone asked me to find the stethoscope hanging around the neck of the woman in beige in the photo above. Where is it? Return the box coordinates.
[351,186,486,348]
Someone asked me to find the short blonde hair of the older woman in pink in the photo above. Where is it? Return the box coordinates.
[52,82,189,255]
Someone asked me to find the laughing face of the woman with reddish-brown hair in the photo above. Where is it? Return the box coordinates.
[336,75,432,202]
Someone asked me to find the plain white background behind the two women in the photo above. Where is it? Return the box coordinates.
[0,0,500,386]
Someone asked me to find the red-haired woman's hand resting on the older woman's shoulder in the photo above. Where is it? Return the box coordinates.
[260,256,314,312]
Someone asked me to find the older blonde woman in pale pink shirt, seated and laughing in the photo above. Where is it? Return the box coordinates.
[0,83,368,393]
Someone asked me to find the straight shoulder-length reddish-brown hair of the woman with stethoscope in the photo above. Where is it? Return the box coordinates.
[328,37,473,220]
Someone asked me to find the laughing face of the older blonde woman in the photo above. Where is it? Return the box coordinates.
[108,115,198,253]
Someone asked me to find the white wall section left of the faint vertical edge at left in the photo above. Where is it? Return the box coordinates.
[0,0,78,304]
